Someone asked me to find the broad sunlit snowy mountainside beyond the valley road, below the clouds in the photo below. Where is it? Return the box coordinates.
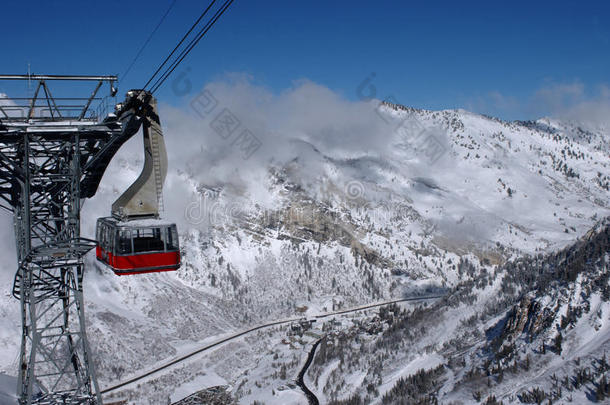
[0,93,610,402]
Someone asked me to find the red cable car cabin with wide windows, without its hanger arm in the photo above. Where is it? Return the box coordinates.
[95,217,180,276]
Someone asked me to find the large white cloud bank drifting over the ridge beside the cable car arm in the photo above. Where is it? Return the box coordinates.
[156,75,400,208]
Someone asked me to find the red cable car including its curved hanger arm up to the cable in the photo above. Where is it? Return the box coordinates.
[95,90,180,275]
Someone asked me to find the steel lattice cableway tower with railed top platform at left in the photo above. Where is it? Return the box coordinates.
[0,75,141,404]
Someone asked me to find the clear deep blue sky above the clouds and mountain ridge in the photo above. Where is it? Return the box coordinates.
[0,0,610,119]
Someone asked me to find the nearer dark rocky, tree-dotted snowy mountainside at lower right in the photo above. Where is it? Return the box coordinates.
[309,216,610,405]
